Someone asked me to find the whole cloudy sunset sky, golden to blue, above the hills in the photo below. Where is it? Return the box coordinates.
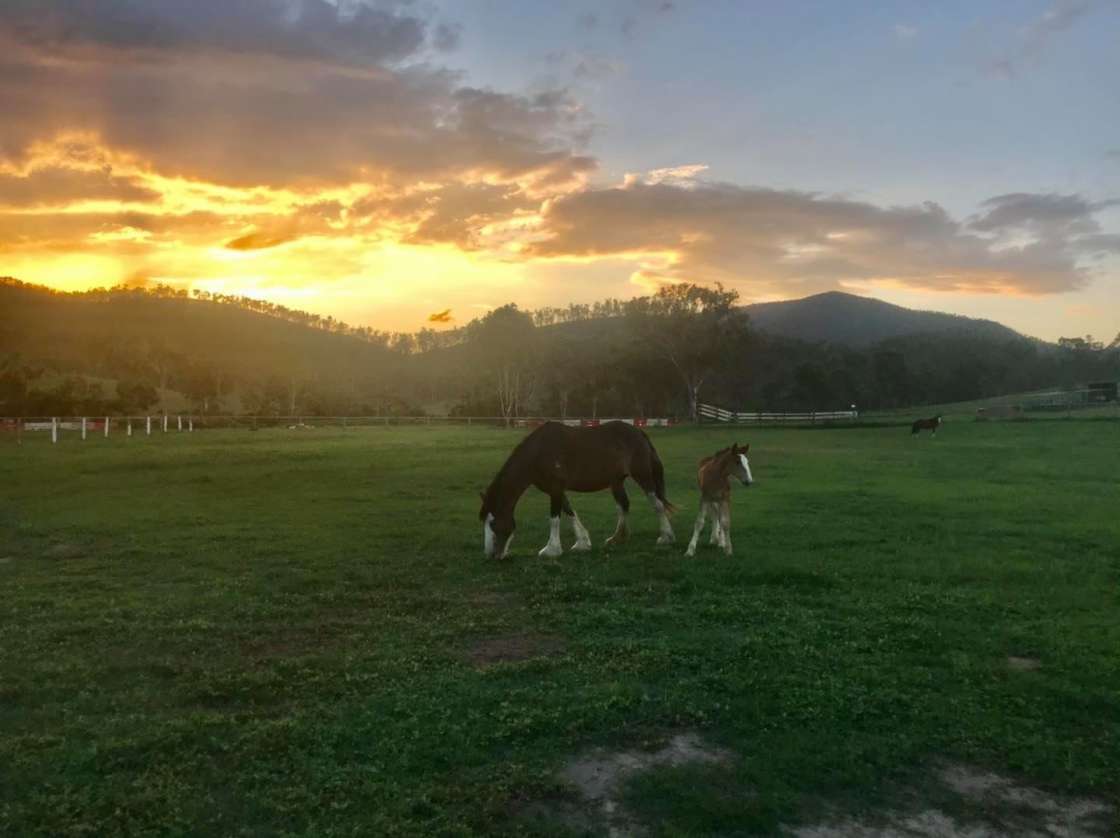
[0,0,1120,339]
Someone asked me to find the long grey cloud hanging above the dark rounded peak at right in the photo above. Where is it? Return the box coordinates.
[531,183,1106,294]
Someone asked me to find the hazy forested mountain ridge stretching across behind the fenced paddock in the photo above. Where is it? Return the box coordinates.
[0,280,1120,416]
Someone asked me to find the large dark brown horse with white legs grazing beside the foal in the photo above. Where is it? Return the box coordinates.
[478,422,673,558]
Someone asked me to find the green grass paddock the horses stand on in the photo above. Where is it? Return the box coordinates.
[0,421,1120,836]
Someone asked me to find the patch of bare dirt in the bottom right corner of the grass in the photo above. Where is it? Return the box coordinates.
[787,764,1117,838]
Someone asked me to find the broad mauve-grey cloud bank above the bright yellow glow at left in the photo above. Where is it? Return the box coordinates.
[0,43,586,185]
